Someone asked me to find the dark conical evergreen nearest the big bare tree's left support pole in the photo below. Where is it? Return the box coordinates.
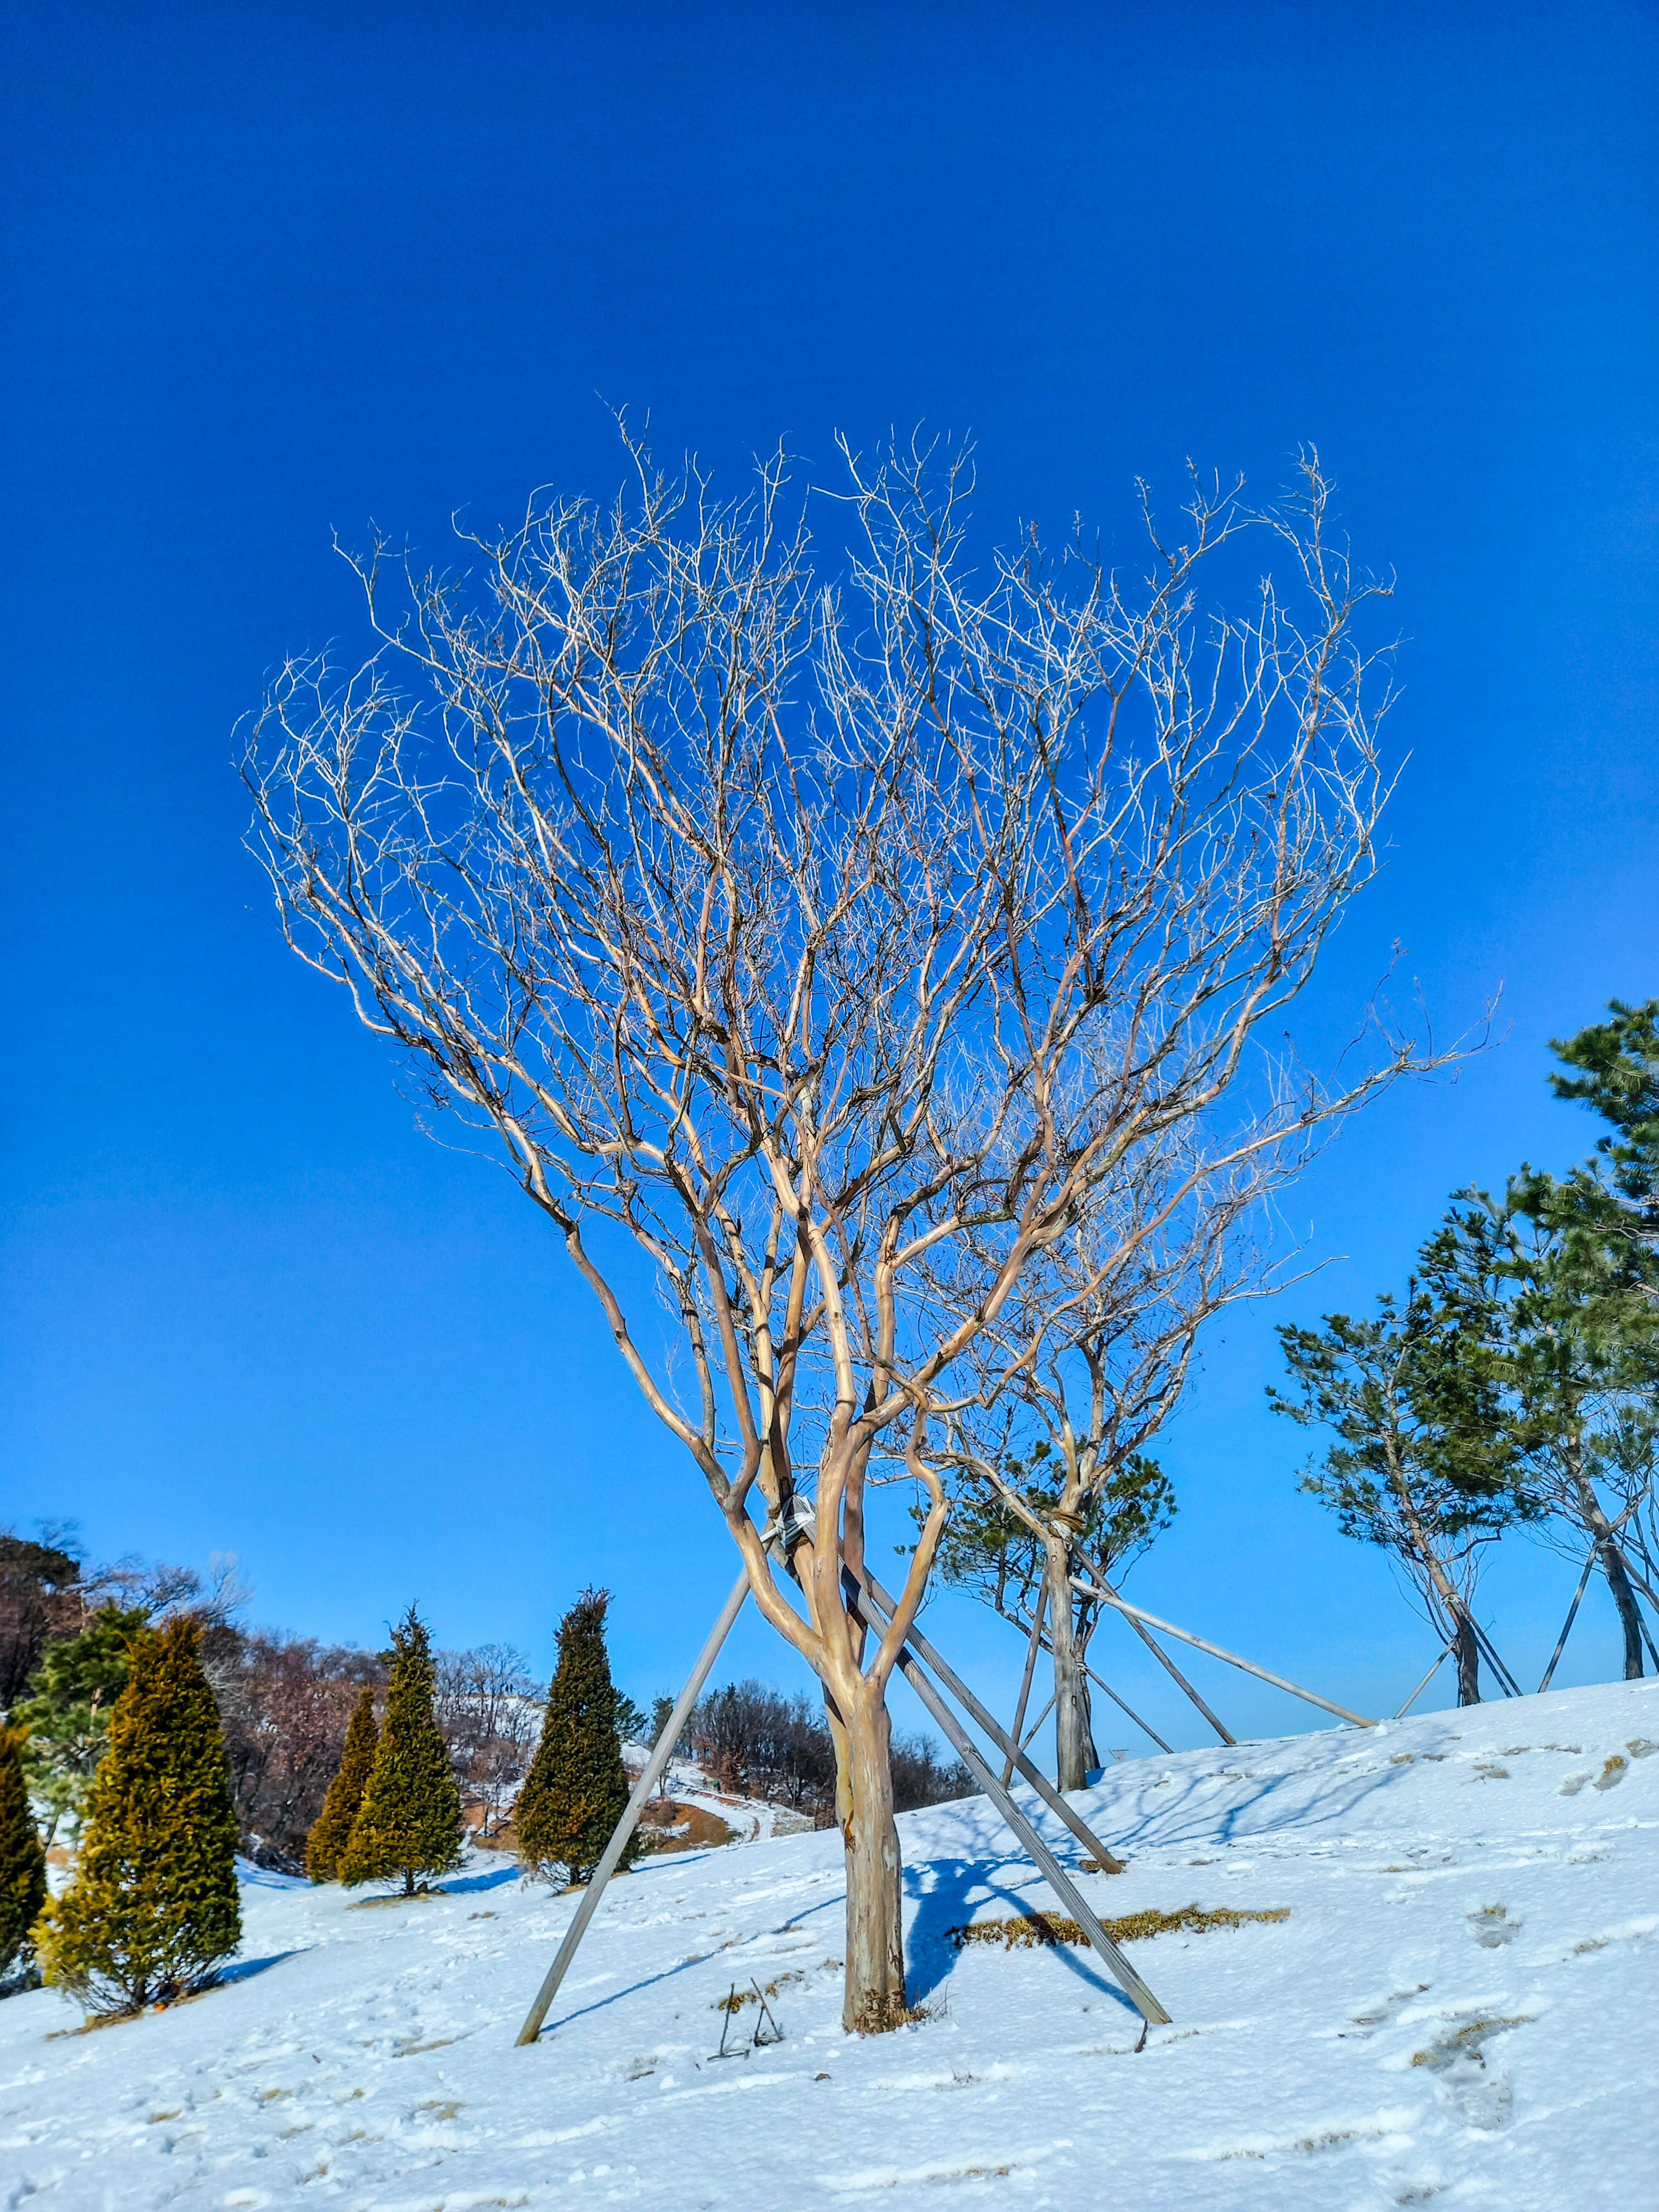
[513,1590,635,1882]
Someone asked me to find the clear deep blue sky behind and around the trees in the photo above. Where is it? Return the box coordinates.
[0,0,1659,1741]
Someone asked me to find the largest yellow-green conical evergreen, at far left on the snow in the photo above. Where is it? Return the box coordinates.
[35,1615,241,2013]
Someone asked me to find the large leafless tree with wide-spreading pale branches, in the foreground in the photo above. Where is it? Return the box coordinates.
[246,422,1411,2031]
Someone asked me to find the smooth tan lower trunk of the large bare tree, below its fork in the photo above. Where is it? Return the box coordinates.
[836,1681,909,2035]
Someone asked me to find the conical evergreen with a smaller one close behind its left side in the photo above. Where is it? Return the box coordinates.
[338,1606,462,1898]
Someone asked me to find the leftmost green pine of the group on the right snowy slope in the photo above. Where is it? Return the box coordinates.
[1267,1232,1535,1705]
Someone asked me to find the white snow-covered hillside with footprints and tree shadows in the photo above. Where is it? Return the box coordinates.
[0,1683,1659,2212]
